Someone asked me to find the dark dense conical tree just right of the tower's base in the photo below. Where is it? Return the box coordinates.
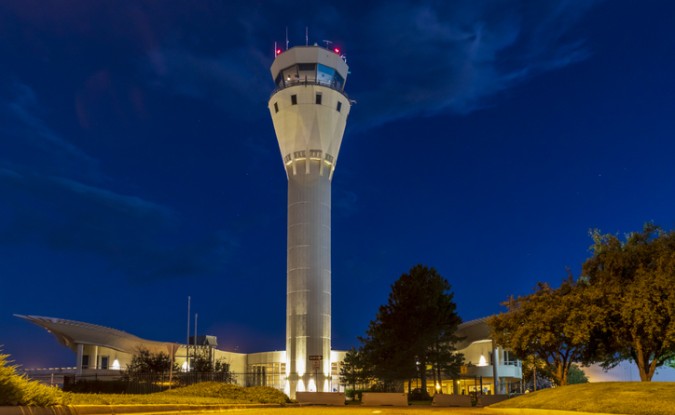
[360,265,462,390]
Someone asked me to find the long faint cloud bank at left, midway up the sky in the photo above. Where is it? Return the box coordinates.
[0,169,238,281]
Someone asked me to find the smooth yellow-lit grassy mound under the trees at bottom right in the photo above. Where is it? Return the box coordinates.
[490,382,675,415]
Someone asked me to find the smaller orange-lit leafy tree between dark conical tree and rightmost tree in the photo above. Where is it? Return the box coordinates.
[488,276,599,385]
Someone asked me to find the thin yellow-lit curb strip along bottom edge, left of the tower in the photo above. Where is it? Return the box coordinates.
[0,404,282,415]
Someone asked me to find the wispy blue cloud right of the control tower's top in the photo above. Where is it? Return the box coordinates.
[344,1,604,125]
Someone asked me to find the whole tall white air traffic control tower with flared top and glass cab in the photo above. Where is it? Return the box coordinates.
[268,46,351,398]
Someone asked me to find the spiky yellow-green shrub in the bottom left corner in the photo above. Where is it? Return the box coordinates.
[0,353,70,406]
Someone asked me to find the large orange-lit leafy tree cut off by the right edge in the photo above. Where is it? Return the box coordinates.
[582,224,675,382]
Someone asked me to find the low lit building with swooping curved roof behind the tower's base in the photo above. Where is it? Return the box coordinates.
[17,315,522,395]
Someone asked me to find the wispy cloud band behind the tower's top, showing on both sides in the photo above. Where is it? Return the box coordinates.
[128,0,596,127]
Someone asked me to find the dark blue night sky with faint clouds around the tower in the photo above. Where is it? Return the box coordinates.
[0,0,675,367]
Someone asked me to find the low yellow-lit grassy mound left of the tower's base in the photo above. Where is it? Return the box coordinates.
[72,382,288,405]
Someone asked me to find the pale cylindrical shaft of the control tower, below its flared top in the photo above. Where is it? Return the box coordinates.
[286,161,331,391]
